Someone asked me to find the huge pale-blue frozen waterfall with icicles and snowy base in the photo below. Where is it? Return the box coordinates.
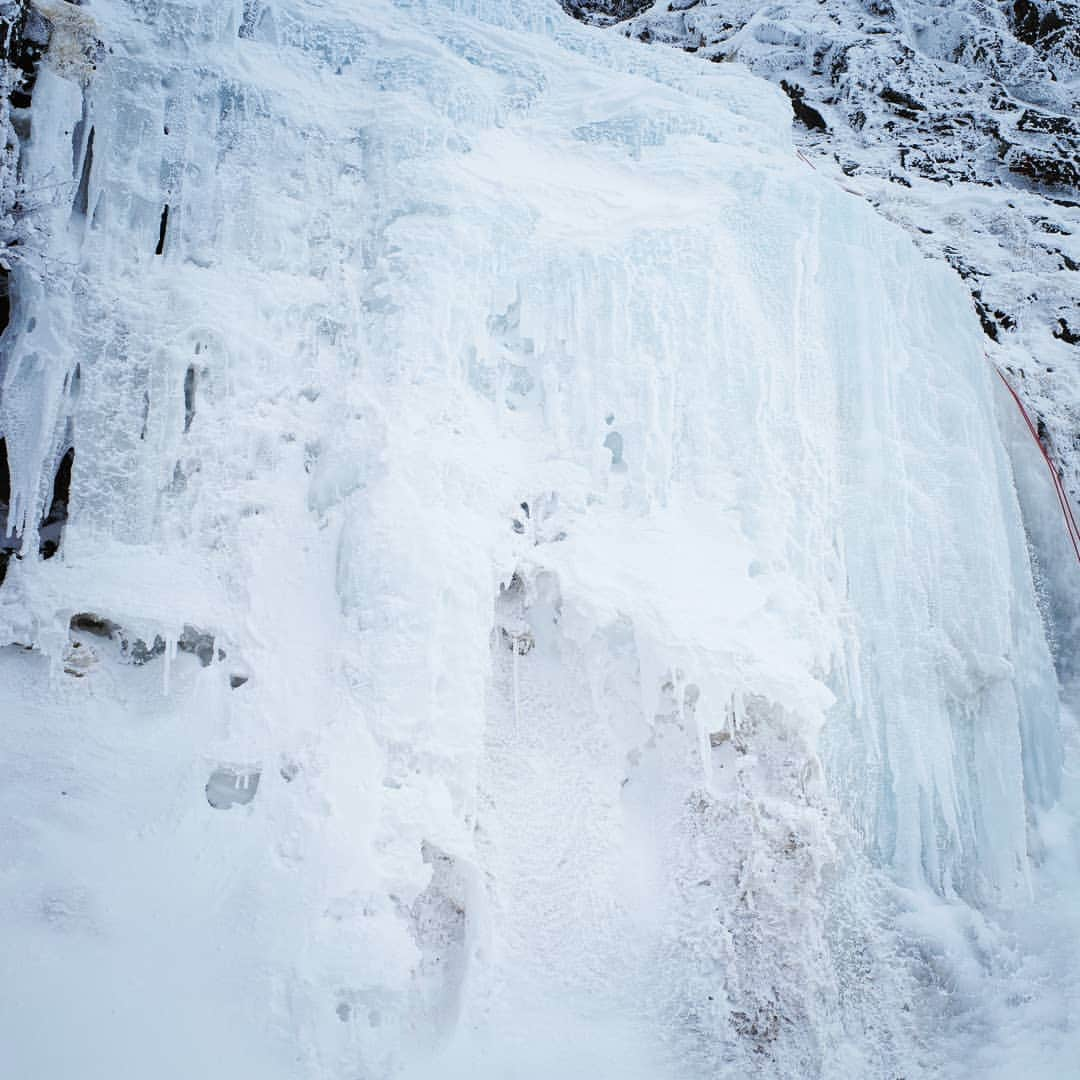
[0,0,1077,1080]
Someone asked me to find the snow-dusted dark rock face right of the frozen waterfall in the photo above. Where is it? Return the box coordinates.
[567,0,1080,570]
